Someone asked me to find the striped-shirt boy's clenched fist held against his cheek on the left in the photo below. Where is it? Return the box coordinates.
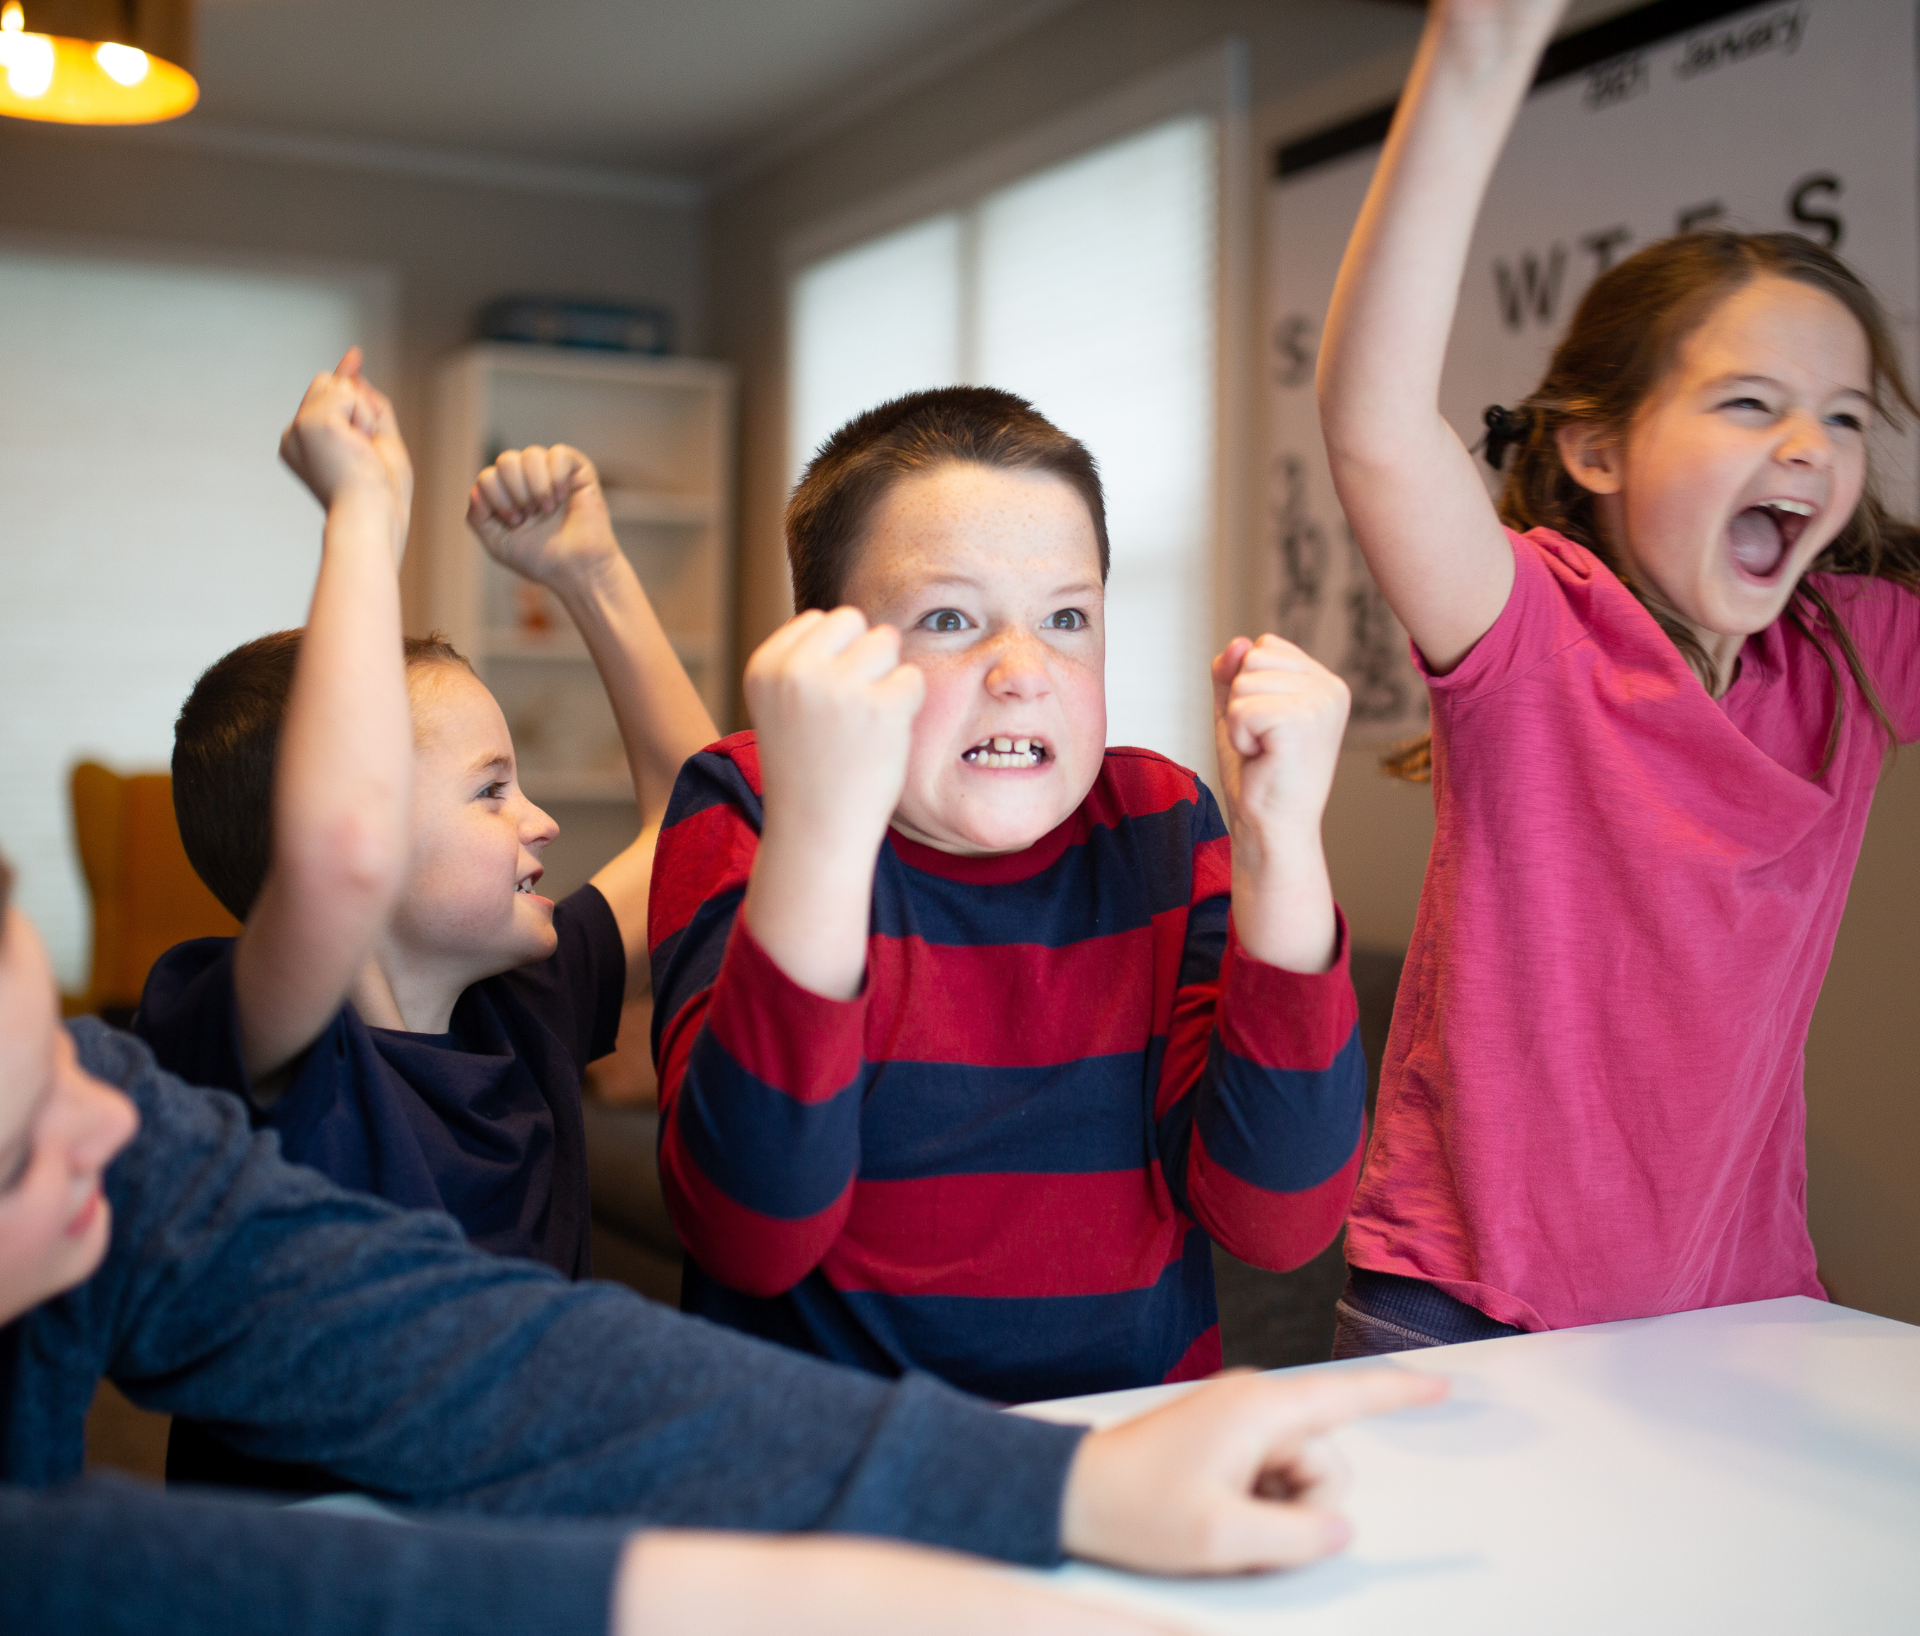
[745,609,925,856]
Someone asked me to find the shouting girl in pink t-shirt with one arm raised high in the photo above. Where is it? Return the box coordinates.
[1319,0,1920,1356]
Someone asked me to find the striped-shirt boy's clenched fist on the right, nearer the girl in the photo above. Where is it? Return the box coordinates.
[1213,636,1350,851]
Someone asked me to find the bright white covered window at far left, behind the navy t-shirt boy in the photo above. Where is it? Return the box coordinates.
[0,255,365,989]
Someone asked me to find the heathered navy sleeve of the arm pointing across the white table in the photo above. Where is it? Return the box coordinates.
[18,1022,1081,1563]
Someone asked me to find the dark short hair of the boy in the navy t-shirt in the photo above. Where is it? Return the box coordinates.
[173,630,472,920]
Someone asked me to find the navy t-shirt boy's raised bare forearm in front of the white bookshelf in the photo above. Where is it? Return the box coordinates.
[549,549,720,824]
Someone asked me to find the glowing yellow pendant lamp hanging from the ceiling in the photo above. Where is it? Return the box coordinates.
[0,0,200,125]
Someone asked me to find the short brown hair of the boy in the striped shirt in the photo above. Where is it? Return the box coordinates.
[787,386,1110,609]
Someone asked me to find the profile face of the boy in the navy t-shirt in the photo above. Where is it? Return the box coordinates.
[390,664,559,987]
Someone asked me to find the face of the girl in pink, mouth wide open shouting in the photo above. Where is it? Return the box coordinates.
[1563,277,1874,651]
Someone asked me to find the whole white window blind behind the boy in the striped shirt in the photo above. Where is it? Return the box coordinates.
[789,115,1217,776]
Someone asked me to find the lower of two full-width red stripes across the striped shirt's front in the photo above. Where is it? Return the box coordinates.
[824,1164,1190,1296]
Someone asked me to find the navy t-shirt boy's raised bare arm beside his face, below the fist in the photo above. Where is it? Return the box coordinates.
[234,486,413,1075]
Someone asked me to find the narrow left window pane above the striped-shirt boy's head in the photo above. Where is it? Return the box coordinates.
[787,215,960,478]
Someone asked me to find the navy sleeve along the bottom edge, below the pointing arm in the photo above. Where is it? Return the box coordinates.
[0,1480,622,1636]
